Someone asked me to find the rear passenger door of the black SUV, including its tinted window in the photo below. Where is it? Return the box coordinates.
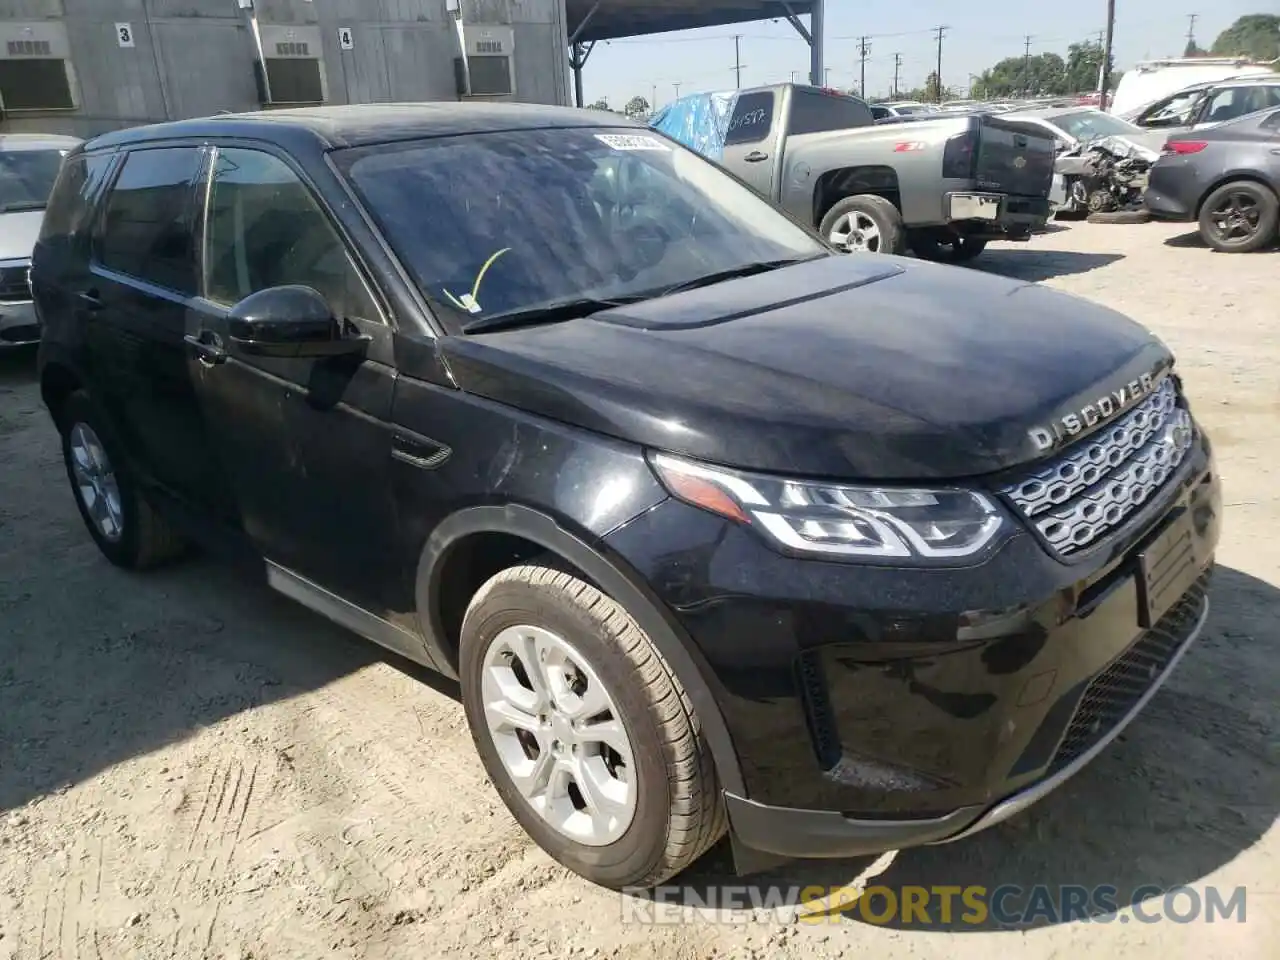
[85,146,238,517]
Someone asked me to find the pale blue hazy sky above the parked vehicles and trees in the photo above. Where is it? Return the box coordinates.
[582,0,1277,109]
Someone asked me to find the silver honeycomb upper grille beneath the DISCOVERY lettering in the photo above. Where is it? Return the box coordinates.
[1002,376,1194,556]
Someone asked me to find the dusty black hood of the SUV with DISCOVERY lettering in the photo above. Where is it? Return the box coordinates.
[442,255,1171,479]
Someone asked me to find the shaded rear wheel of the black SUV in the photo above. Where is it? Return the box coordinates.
[59,390,186,570]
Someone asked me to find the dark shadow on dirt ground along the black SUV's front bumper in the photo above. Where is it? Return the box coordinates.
[678,566,1280,932]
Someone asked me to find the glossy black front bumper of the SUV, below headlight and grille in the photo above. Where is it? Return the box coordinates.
[608,436,1221,858]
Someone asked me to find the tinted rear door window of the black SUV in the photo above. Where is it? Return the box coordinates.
[96,147,200,293]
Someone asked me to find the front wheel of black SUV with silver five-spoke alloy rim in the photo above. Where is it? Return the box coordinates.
[458,564,726,890]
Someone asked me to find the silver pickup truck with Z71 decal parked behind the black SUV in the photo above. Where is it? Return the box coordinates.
[675,83,1055,262]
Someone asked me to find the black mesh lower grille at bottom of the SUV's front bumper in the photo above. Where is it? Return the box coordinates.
[1048,572,1210,774]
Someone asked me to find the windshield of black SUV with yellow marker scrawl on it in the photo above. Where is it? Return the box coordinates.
[338,127,828,328]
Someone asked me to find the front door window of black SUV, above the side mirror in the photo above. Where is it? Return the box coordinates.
[205,150,380,320]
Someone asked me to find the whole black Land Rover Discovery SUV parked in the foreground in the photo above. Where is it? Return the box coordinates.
[32,104,1220,887]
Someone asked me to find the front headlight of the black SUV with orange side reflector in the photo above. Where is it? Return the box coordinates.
[650,453,1005,559]
